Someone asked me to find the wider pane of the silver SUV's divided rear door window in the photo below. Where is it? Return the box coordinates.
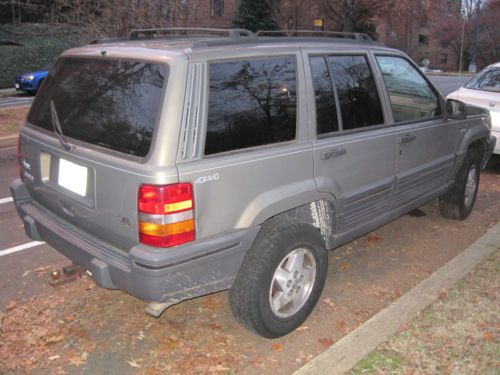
[328,56,384,130]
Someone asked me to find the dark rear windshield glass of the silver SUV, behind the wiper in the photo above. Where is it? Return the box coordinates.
[28,58,168,157]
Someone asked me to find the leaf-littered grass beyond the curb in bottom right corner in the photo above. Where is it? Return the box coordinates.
[350,250,500,375]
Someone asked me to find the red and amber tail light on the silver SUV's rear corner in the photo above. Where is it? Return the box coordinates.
[139,183,196,247]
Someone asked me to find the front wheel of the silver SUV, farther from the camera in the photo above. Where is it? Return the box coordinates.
[439,148,481,220]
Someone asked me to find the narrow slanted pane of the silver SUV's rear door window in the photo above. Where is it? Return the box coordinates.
[311,57,339,134]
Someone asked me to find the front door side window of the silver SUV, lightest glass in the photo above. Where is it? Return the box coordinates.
[377,56,441,122]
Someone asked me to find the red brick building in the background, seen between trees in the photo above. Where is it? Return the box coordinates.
[169,0,461,71]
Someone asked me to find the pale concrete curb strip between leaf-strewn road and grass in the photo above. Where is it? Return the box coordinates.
[294,223,500,375]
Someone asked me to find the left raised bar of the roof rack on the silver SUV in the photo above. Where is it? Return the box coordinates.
[128,27,255,40]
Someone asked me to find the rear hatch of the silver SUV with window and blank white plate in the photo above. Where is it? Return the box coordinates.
[21,57,178,251]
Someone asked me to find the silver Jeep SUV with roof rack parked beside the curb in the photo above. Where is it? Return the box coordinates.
[11,29,495,337]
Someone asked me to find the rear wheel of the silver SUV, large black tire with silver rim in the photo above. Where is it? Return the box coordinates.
[229,222,328,338]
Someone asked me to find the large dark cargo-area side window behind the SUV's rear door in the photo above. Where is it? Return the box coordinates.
[205,57,296,155]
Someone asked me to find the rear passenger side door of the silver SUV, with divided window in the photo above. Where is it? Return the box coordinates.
[307,53,396,234]
